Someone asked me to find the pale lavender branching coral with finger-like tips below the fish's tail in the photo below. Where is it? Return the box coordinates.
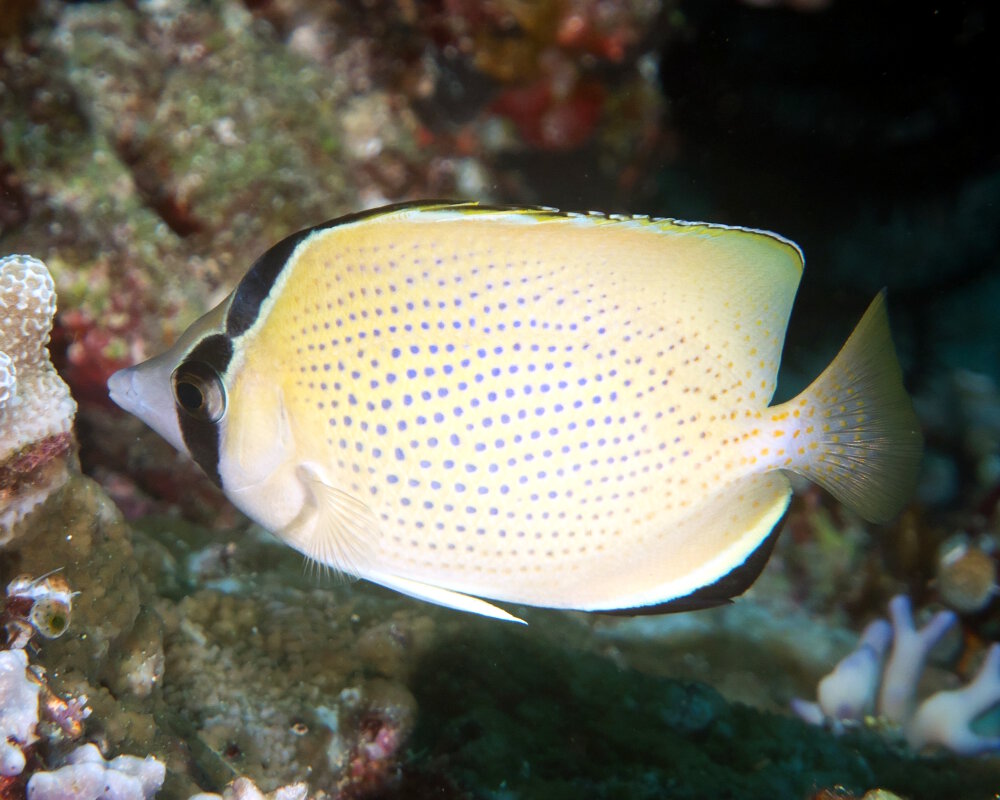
[792,595,1000,755]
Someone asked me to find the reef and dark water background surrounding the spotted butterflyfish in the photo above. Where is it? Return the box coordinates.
[0,0,1000,800]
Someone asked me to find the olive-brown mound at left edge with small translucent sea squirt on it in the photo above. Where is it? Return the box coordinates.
[0,472,166,792]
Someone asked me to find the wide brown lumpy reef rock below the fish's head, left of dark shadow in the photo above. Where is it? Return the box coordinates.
[0,474,434,797]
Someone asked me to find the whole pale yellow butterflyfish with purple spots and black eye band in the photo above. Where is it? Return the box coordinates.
[109,203,922,619]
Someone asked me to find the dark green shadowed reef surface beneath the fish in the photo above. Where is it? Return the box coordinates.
[402,625,1000,800]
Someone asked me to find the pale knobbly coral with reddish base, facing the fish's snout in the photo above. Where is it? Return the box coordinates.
[0,255,76,546]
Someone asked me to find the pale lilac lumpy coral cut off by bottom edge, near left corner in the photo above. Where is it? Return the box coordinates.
[28,744,166,800]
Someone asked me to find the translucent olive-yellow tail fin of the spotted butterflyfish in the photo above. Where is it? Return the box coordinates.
[790,290,923,522]
